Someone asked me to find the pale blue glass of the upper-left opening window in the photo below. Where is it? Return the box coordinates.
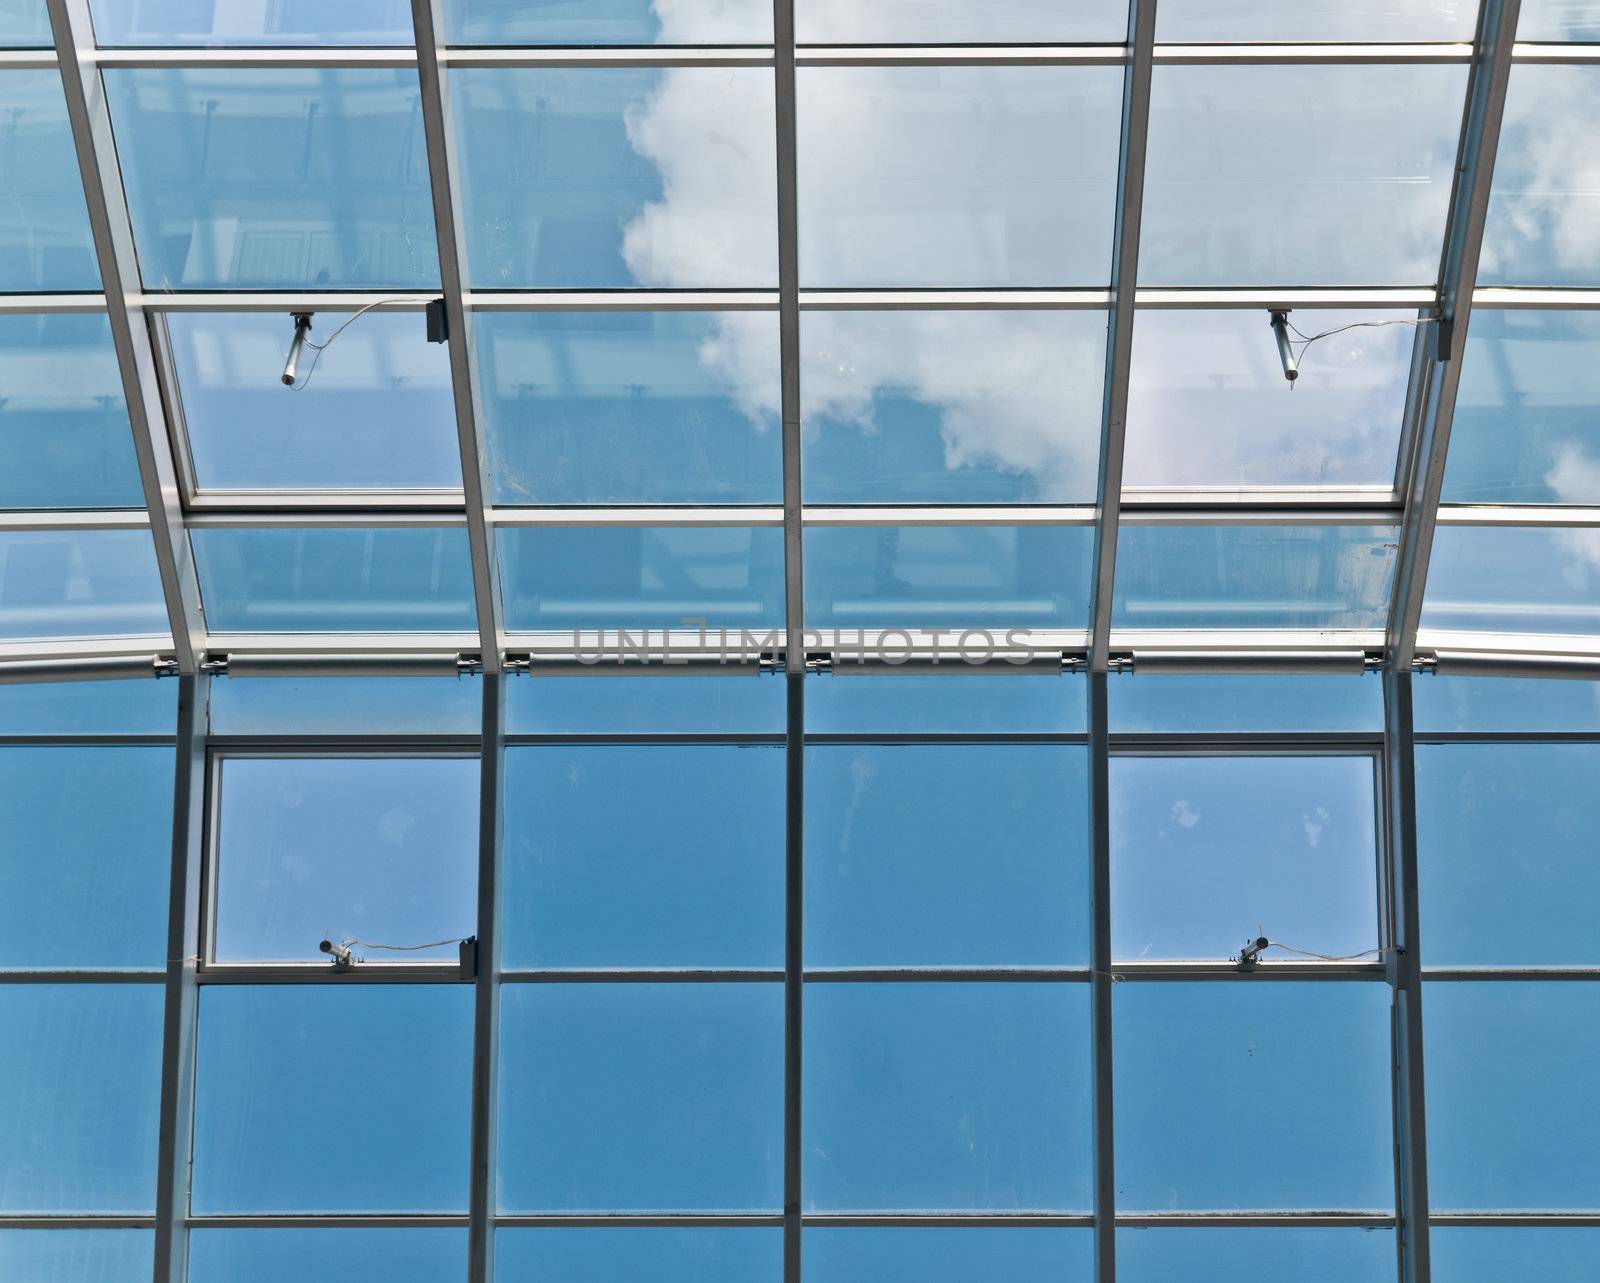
[165,312,461,491]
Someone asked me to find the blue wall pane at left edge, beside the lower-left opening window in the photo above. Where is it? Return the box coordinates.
[0,745,173,969]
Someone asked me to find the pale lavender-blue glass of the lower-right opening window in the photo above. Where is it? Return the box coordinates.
[1110,755,1378,961]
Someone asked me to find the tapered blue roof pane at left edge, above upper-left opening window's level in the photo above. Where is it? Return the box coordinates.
[0,71,99,293]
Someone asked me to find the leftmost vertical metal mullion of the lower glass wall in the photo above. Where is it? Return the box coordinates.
[152,673,211,1283]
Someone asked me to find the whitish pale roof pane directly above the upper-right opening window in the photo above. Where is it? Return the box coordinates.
[1145,66,1467,286]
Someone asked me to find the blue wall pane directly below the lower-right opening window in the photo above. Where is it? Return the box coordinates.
[1114,981,1401,1209]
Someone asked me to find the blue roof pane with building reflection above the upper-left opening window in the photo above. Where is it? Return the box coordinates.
[104,67,438,291]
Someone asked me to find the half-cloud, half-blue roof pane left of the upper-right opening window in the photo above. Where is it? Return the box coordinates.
[806,310,1106,504]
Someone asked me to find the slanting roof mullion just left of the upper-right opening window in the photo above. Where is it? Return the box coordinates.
[1090,0,1155,672]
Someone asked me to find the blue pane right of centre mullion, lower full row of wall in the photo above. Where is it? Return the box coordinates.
[802,982,1093,1213]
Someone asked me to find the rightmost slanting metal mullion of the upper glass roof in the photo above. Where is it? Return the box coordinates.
[1384,0,1522,670]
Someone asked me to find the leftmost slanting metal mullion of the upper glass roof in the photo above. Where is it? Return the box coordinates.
[48,0,205,673]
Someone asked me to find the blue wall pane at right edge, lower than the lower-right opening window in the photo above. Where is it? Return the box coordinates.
[1422,979,1600,1211]
